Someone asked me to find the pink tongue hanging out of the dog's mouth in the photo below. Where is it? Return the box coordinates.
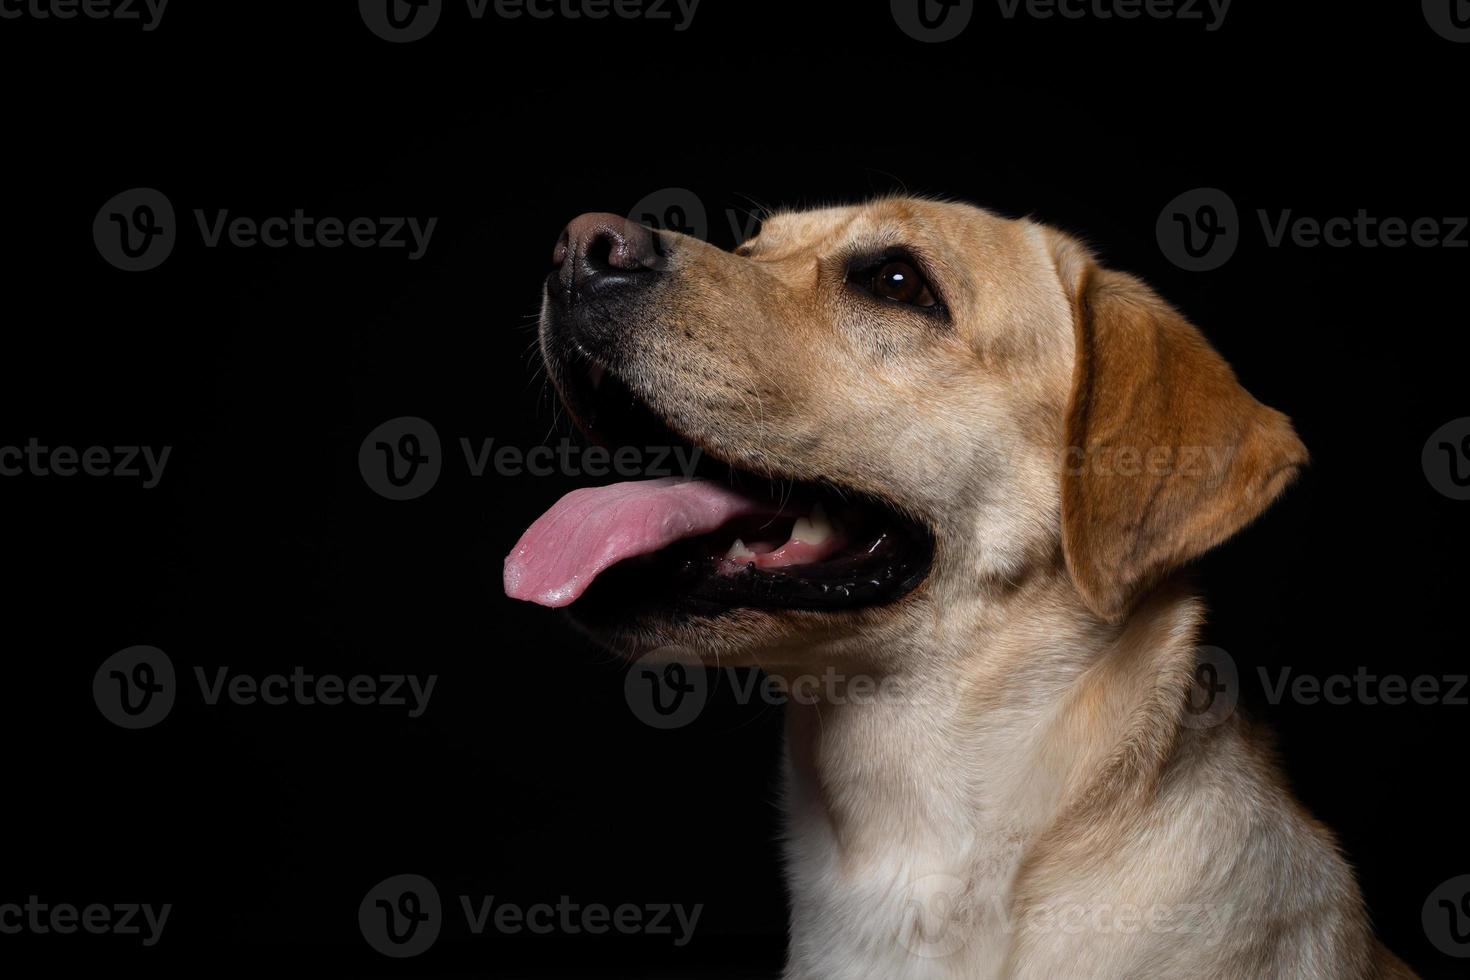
[506,478,776,607]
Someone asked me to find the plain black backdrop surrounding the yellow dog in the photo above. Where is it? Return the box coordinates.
[0,0,1470,977]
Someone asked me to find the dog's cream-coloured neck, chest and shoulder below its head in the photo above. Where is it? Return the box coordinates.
[785,582,1408,980]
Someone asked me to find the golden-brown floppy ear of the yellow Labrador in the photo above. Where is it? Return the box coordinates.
[1053,234,1307,621]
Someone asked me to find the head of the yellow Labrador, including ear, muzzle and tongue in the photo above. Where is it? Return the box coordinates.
[506,198,1305,658]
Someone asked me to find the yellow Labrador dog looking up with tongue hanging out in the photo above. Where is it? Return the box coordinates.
[504,197,1413,980]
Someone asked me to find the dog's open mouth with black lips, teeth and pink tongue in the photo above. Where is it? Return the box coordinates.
[504,354,933,619]
